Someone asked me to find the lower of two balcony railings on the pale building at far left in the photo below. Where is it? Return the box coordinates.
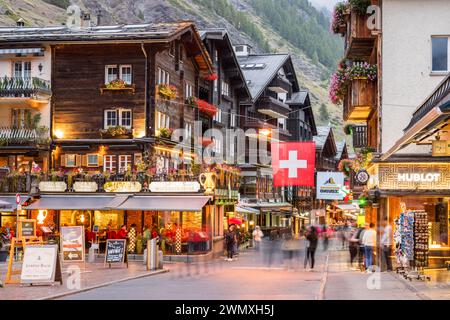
[0,127,50,147]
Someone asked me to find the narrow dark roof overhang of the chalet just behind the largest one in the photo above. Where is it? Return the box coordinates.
[199,29,251,100]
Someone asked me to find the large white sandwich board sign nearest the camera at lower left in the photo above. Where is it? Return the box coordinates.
[20,245,62,285]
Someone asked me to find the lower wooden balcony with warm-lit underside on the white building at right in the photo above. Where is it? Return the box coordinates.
[343,79,377,121]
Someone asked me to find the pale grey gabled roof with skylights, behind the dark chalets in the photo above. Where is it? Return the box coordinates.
[238,54,300,101]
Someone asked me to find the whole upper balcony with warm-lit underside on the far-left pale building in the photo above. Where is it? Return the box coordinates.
[0,77,52,107]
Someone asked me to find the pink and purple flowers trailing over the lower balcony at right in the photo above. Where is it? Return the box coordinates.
[329,62,378,104]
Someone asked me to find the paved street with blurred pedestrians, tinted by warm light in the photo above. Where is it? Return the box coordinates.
[55,241,449,300]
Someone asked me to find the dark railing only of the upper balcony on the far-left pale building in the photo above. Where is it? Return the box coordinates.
[0,77,52,98]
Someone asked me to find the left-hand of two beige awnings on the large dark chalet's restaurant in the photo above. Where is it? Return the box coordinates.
[23,195,116,210]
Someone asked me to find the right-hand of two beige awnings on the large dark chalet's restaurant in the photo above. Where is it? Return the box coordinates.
[117,196,210,211]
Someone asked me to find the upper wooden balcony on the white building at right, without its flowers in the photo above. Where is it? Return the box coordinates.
[345,11,375,61]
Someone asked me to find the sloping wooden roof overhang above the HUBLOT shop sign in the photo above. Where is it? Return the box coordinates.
[381,75,450,160]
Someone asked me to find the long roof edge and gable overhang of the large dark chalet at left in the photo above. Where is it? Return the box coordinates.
[0,21,214,73]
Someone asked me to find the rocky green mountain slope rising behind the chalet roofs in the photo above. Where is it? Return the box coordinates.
[0,0,342,135]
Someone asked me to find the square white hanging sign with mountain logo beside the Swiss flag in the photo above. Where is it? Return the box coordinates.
[316,172,345,200]
